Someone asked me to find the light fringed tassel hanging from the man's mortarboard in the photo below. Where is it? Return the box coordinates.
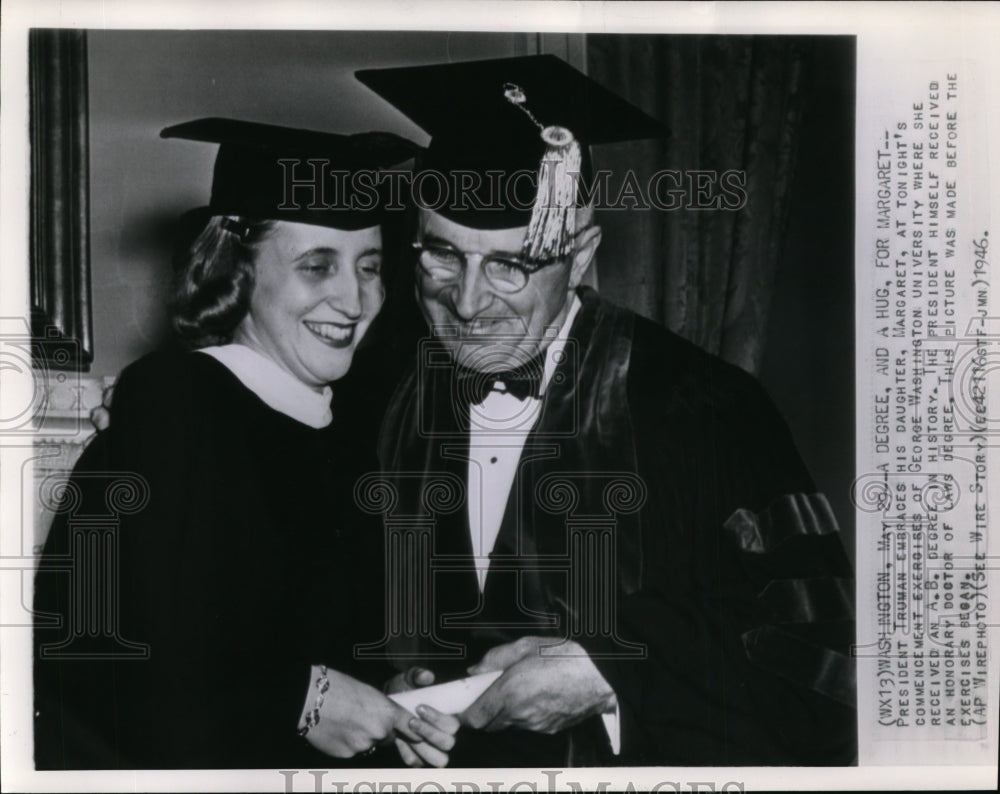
[504,83,582,260]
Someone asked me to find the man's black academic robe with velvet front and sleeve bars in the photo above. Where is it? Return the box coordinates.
[380,289,856,766]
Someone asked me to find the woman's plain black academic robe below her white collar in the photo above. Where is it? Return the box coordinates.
[34,353,381,769]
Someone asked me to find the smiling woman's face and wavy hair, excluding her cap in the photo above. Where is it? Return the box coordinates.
[171,216,384,390]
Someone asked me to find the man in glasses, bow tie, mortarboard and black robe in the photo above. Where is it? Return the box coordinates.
[358,56,856,767]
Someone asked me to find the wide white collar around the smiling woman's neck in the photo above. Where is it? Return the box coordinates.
[198,344,333,428]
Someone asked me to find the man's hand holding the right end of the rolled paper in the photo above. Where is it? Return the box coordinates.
[459,637,618,733]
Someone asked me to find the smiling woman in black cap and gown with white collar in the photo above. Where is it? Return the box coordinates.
[35,119,458,769]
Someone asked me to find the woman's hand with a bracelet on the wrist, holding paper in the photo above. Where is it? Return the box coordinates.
[299,667,458,766]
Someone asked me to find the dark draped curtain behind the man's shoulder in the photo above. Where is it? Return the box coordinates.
[587,35,809,373]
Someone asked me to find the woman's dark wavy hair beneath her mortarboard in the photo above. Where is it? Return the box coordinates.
[169,211,277,348]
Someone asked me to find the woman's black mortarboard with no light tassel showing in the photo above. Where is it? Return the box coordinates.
[160,118,420,231]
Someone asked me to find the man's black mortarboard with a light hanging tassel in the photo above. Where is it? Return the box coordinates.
[355,55,668,259]
